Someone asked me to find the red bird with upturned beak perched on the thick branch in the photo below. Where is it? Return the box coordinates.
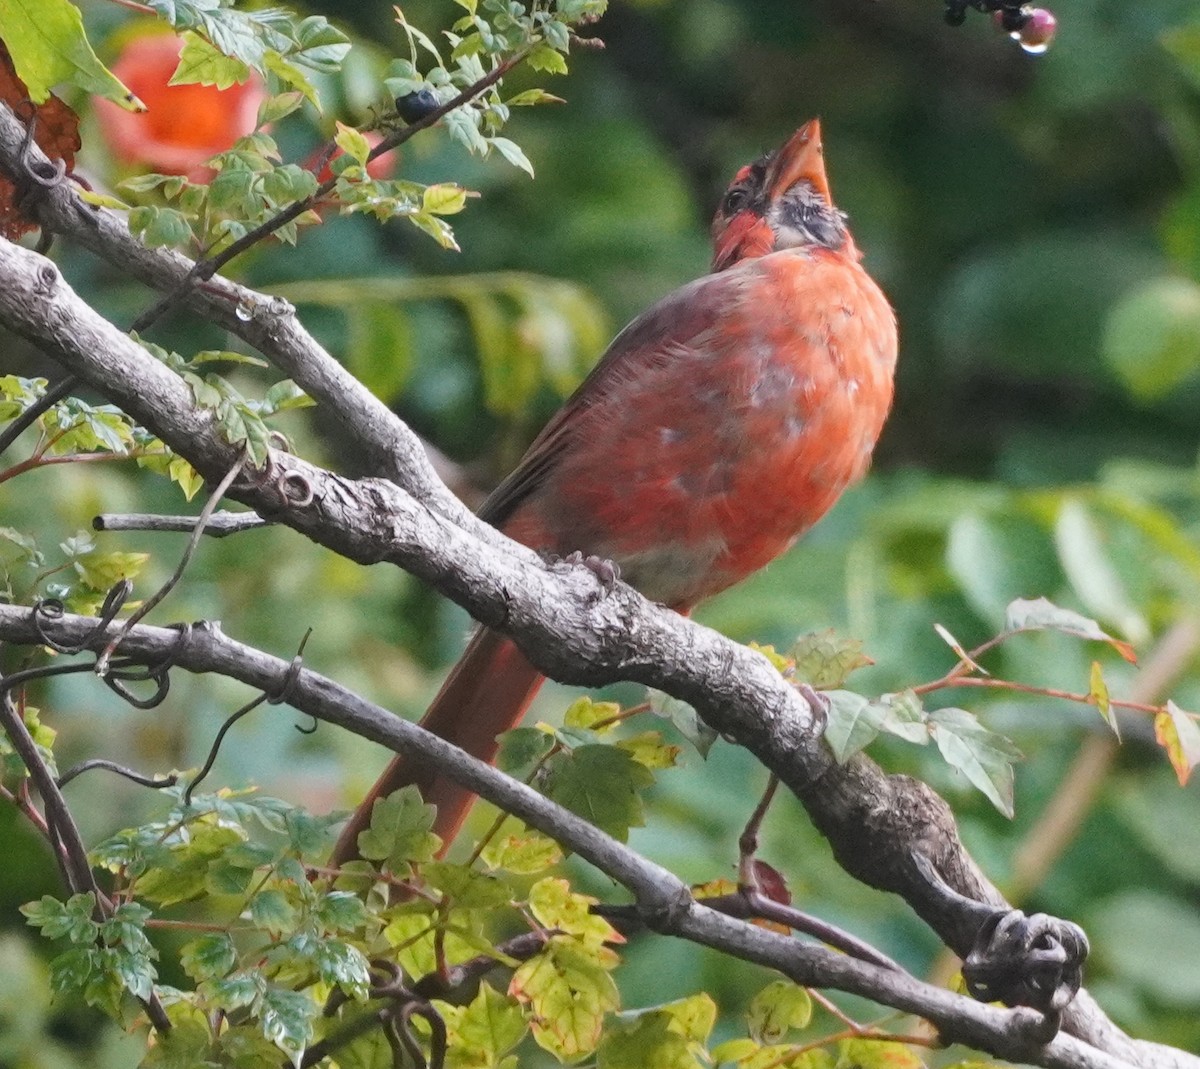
[334,120,898,863]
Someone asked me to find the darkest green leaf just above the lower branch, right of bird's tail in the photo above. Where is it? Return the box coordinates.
[545,745,654,842]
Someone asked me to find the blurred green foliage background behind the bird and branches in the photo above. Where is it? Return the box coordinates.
[0,0,1200,1067]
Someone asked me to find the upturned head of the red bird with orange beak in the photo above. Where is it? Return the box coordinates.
[713,119,857,271]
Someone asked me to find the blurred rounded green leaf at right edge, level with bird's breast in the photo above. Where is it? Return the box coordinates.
[1104,277,1200,404]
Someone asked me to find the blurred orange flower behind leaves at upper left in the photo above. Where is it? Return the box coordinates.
[96,34,266,180]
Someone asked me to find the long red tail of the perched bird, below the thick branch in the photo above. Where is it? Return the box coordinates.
[331,629,546,865]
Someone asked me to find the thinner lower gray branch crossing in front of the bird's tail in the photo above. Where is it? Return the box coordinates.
[0,606,1132,1069]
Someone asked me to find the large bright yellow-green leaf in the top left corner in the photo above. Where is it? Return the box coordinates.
[0,0,145,112]
